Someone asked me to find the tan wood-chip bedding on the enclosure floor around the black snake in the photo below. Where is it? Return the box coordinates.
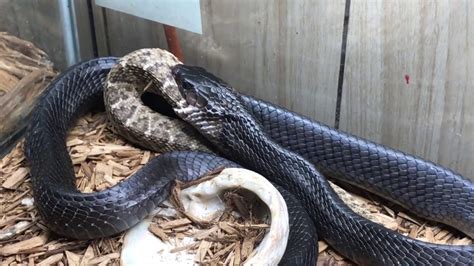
[0,113,473,265]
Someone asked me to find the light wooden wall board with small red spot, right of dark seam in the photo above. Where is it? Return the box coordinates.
[341,0,474,177]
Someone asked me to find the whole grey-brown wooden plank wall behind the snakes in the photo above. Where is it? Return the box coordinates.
[0,0,474,179]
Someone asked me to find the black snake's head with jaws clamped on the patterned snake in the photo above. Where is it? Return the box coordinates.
[172,65,252,147]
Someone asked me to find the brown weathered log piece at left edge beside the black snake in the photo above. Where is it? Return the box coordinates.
[0,32,56,155]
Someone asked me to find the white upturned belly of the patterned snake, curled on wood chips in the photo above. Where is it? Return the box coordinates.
[121,168,289,266]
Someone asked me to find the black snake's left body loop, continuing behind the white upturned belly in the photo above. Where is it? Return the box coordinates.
[25,58,317,265]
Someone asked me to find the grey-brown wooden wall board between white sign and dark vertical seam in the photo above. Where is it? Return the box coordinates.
[179,0,345,125]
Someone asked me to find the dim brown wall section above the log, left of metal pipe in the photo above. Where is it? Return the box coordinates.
[0,0,66,69]
